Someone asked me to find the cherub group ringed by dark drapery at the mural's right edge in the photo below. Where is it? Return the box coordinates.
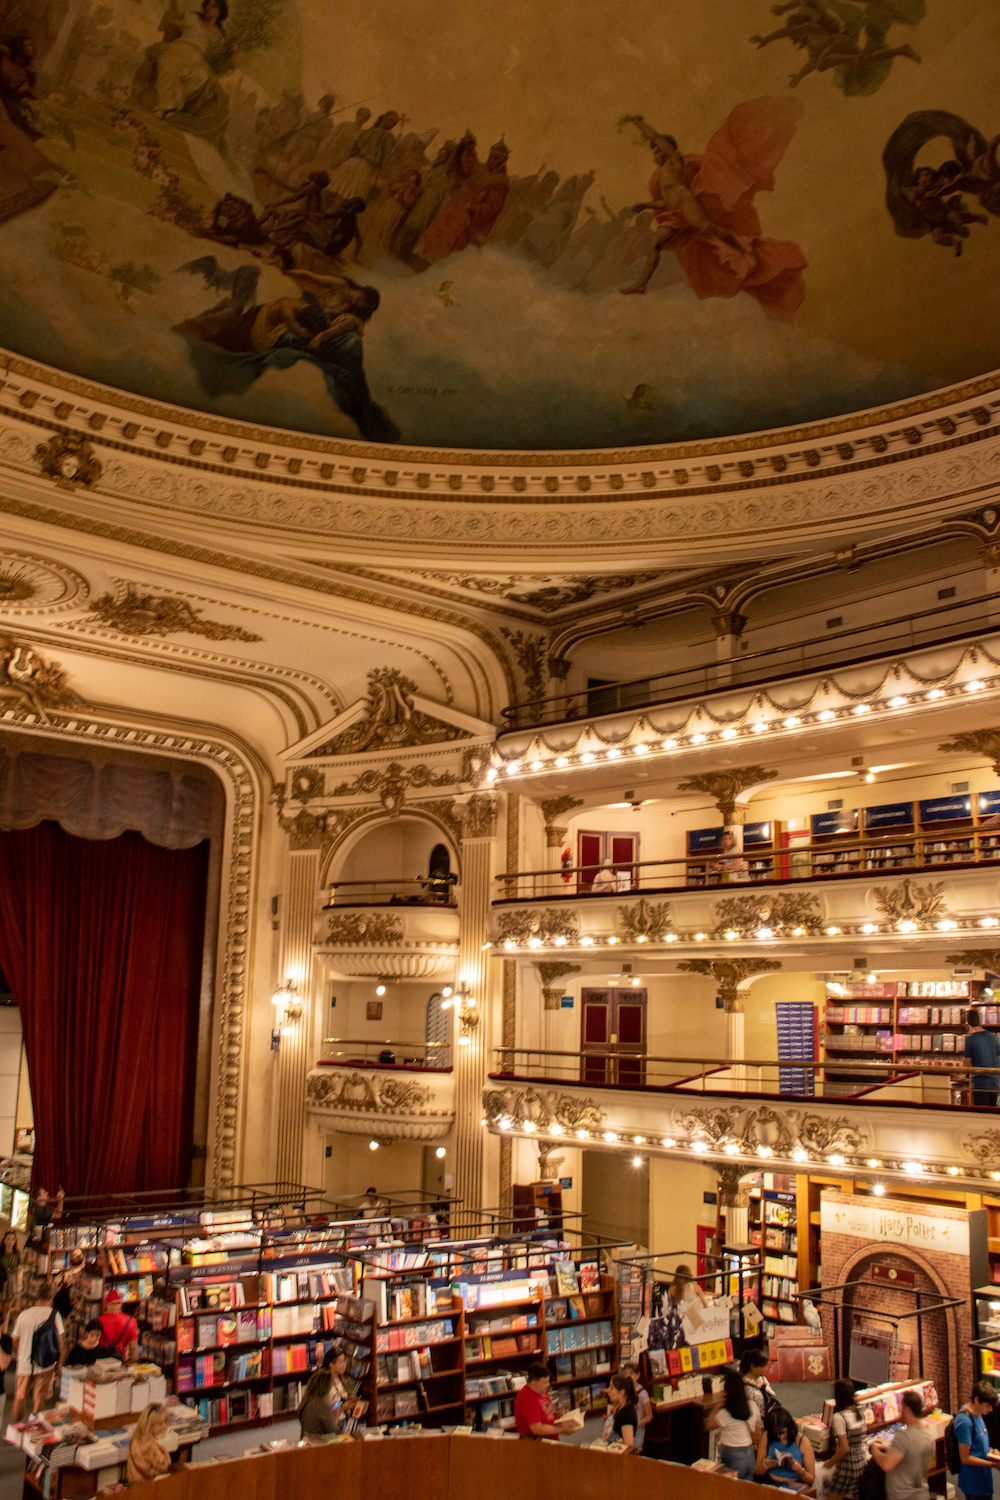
[882,110,1000,255]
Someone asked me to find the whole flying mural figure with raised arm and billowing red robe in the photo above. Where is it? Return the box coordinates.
[622,98,808,323]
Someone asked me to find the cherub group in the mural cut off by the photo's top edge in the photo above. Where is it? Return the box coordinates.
[750,0,925,95]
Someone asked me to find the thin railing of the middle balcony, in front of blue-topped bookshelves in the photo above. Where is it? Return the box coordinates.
[493,819,1000,905]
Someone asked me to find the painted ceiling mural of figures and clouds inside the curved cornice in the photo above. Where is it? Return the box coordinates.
[0,0,1000,447]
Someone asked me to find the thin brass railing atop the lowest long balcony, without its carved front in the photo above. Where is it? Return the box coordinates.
[490,1047,1000,1107]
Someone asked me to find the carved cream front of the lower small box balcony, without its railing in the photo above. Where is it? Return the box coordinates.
[306,1064,454,1140]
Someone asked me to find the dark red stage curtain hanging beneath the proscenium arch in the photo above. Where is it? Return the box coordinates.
[0,822,208,1196]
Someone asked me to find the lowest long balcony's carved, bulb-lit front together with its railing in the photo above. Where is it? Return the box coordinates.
[483,1049,1000,1193]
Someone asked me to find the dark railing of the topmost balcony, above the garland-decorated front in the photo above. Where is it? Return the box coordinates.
[499,594,997,734]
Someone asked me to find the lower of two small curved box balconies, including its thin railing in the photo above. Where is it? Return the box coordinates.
[306,1038,454,1140]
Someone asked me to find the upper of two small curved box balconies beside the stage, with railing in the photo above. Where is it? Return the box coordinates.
[313,881,459,980]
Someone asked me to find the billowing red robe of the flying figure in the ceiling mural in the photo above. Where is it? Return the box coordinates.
[649,99,808,323]
